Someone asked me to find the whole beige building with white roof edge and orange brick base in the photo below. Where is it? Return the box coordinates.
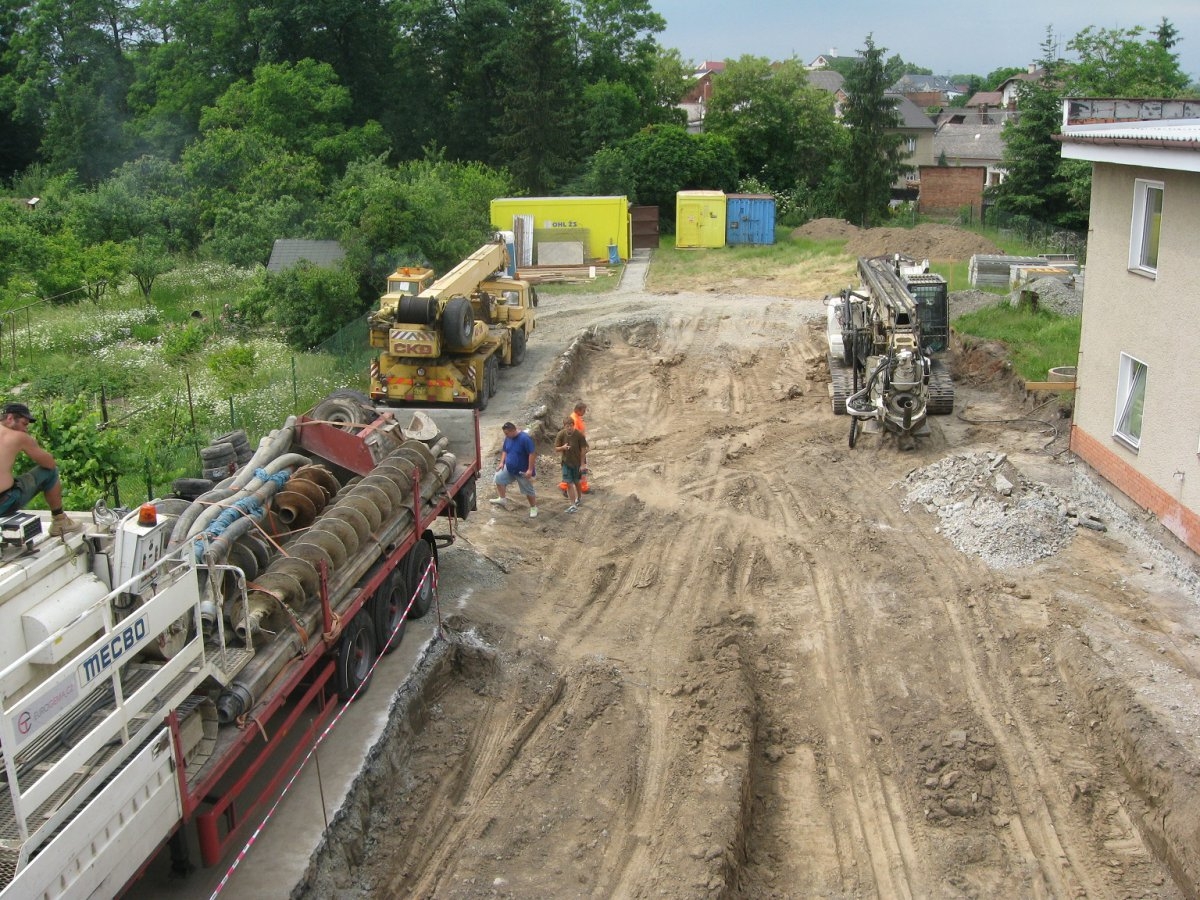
[1057,100,1200,552]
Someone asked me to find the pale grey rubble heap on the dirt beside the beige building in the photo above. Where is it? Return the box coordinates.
[900,452,1075,569]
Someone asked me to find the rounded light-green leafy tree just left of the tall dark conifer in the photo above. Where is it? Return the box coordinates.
[704,56,841,191]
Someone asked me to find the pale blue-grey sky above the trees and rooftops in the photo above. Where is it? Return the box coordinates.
[650,0,1200,82]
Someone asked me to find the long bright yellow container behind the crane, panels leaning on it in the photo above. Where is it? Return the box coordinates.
[491,197,634,266]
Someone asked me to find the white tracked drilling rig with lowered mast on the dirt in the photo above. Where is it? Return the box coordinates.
[826,254,954,448]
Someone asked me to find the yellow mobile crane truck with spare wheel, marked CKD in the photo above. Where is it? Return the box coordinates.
[370,240,538,409]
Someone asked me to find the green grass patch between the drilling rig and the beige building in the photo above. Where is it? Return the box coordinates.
[954,304,1080,382]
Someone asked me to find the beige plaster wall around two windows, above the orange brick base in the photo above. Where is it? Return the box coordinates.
[1075,163,1200,524]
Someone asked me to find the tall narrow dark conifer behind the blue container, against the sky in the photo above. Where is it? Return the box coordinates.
[836,35,908,228]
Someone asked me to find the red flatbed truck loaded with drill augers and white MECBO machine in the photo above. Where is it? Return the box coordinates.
[0,391,480,900]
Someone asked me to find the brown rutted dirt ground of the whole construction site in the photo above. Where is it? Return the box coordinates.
[294,241,1200,899]
